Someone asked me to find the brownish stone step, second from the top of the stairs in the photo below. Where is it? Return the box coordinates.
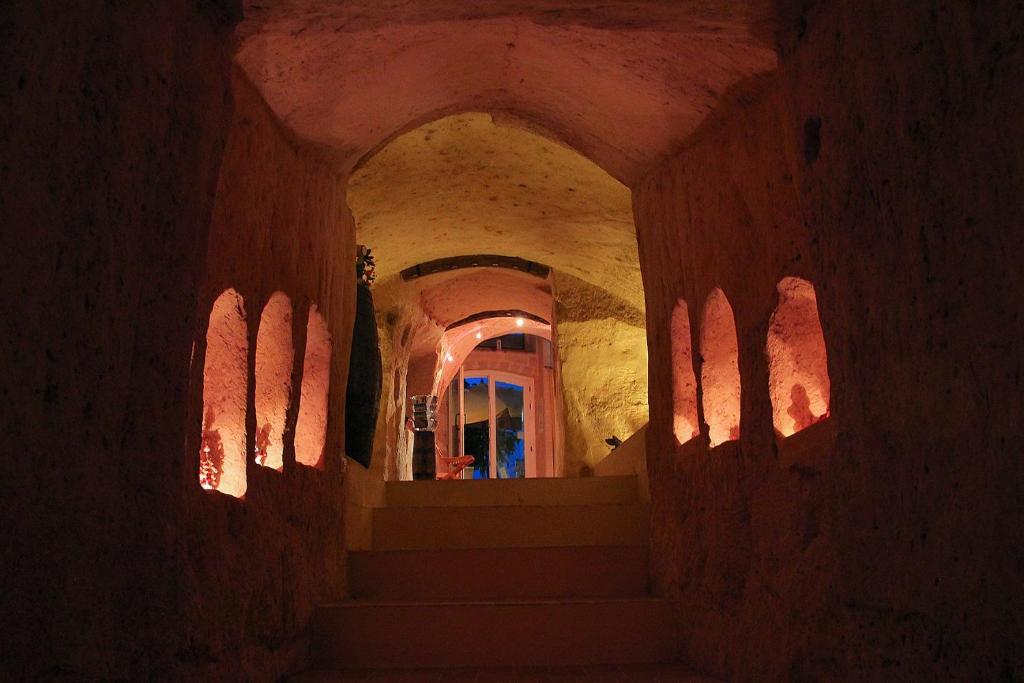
[373,505,648,550]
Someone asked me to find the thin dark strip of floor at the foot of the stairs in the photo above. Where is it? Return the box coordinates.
[292,665,717,683]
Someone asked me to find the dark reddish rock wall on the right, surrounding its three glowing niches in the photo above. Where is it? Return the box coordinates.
[635,0,1024,680]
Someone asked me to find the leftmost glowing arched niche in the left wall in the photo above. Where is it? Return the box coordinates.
[199,290,249,498]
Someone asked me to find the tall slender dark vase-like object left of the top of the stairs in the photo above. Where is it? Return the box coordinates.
[345,285,382,467]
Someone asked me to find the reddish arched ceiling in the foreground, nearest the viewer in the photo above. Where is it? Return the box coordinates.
[238,0,776,184]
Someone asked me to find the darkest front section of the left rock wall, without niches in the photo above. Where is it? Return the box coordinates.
[0,0,241,680]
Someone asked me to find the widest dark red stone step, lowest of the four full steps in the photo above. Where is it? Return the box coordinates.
[311,597,677,670]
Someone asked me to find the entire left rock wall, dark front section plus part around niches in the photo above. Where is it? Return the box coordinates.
[0,1,351,680]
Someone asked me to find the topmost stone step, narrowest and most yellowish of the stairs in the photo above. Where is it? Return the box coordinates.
[385,475,638,507]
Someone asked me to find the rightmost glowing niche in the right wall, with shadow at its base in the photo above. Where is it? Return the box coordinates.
[765,278,830,436]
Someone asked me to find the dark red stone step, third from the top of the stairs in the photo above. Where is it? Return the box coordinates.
[348,546,647,600]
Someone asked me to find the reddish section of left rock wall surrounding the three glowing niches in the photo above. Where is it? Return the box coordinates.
[183,74,355,680]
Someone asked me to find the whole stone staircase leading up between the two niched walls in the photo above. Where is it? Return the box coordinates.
[311,476,677,672]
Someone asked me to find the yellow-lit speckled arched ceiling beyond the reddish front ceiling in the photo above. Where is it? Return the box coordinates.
[348,114,643,309]
